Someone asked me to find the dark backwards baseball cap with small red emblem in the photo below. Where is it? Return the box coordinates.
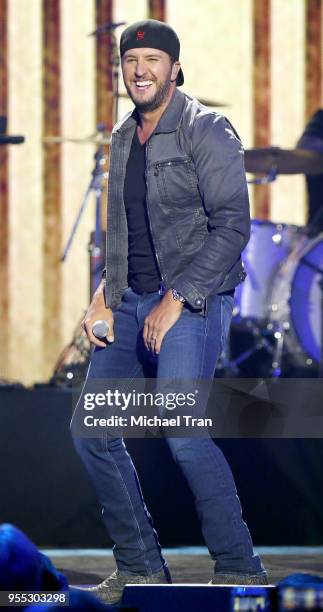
[120,19,184,85]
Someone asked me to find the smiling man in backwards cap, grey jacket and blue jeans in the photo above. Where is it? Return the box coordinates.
[74,20,267,603]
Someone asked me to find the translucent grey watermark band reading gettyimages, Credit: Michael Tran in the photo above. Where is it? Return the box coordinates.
[71,378,323,438]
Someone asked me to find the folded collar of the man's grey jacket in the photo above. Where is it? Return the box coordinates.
[113,88,186,134]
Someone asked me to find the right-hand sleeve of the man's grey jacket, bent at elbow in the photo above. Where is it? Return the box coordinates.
[174,113,250,308]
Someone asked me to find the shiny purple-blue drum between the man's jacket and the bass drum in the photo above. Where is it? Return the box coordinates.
[233,219,302,326]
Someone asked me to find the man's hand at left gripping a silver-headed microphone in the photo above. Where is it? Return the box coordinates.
[81,279,114,348]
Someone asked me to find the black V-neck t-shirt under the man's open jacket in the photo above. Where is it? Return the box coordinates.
[123,130,161,293]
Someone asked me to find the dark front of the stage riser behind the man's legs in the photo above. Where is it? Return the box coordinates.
[0,388,323,547]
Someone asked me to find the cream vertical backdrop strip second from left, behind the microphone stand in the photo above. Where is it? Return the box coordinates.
[58,0,97,349]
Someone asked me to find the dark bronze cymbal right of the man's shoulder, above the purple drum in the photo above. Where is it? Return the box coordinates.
[245,147,323,174]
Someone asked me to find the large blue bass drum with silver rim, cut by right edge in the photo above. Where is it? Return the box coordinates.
[270,233,323,364]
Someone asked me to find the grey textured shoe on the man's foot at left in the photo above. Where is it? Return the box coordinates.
[77,569,170,604]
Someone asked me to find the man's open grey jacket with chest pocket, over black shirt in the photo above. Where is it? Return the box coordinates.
[105,89,250,313]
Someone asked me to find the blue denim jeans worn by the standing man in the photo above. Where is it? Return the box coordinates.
[74,287,265,576]
